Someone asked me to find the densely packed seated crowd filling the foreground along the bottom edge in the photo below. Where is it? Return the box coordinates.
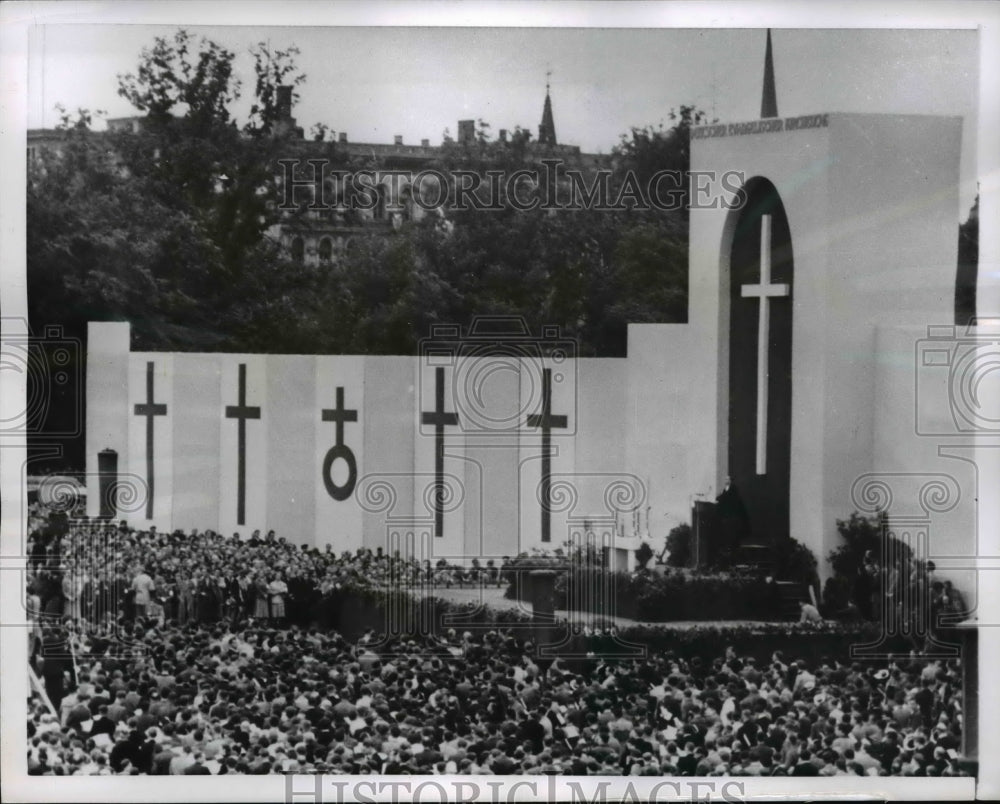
[28,618,966,776]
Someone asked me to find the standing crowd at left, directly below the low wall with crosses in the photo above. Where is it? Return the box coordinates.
[28,521,510,636]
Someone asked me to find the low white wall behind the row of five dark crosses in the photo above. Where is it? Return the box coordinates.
[87,324,630,560]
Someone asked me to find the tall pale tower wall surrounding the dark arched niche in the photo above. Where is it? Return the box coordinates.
[689,113,961,573]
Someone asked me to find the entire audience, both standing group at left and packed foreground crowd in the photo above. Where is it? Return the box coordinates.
[27,525,966,776]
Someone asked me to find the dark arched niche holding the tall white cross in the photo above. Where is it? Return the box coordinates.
[723,178,794,544]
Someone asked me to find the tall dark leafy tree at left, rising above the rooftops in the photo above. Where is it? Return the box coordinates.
[27,31,316,468]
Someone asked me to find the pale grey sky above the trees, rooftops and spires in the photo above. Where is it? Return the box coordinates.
[27,24,979,209]
